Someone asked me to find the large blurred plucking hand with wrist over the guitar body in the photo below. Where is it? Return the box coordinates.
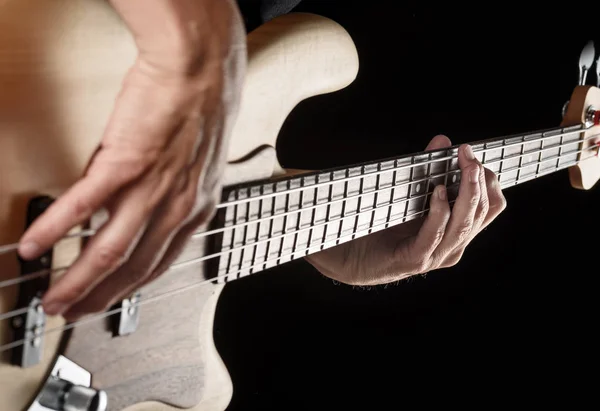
[19,0,246,320]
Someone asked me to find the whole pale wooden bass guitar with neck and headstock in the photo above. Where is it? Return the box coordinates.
[0,0,600,411]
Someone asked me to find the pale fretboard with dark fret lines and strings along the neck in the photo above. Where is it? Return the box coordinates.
[206,126,593,282]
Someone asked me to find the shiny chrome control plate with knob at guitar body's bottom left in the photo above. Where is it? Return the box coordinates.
[27,355,108,411]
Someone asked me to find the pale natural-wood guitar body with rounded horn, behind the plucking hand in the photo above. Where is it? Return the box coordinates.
[0,0,358,411]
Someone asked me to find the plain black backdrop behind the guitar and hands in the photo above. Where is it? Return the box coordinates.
[215,0,600,411]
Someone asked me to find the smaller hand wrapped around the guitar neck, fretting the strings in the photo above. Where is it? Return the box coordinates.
[306,136,506,285]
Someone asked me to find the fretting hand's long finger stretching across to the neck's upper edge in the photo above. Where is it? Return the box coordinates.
[435,145,481,259]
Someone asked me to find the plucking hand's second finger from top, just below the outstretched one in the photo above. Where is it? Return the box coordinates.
[42,180,155,315]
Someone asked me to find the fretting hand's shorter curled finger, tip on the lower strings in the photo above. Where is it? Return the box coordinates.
[398,185,450,273]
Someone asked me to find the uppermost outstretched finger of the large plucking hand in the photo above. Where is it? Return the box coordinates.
[19,150,150,260]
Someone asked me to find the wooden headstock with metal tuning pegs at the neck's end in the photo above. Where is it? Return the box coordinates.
[561,41,600,190]
